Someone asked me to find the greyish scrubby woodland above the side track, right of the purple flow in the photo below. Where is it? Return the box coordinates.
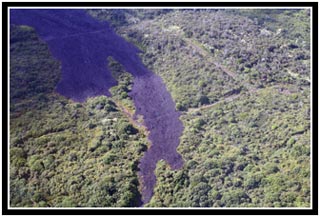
[92,10,310,111]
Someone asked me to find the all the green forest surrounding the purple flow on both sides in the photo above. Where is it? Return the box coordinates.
[10,9,311,207]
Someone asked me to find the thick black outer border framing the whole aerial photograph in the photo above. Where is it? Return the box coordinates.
[2,2,318,215]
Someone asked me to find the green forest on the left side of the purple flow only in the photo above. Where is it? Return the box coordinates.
[10,26,148,207]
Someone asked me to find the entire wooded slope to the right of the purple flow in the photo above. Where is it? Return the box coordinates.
[91,10,310,207]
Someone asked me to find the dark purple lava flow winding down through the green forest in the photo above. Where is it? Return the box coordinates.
[10,9,183,203]
